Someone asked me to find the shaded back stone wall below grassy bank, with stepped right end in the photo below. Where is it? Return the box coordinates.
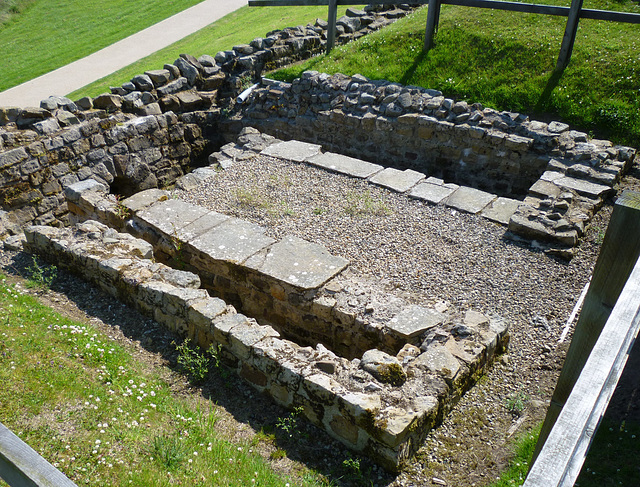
[225,71,636,257]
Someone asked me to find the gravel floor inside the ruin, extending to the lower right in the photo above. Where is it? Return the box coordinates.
[174,152,611,487]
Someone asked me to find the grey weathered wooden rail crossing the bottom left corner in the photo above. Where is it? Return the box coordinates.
[0,423,76,487]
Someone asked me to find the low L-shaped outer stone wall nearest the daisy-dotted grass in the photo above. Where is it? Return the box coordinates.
[25,221,504,470]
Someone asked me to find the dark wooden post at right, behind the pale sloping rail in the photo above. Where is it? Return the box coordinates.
[532,191,640,464]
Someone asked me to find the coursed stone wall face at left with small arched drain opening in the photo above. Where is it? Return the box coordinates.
[0,112,211,234]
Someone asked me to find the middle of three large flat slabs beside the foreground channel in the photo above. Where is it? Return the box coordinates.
[189,218,275,264]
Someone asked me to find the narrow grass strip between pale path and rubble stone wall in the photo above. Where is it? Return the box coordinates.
[69,7,358,100]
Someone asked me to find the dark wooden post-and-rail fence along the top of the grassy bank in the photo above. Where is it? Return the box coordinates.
[249,0,640,69]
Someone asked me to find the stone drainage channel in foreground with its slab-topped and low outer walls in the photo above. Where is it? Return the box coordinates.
[58,173,508,470]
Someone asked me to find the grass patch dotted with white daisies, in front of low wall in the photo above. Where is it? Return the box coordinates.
[0,273,328,487]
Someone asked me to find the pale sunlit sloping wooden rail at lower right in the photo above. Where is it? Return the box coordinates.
[523,195,640,487]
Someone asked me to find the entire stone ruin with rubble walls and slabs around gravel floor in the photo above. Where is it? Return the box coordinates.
[0,0,636,470]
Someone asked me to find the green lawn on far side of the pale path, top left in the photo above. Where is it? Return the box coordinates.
[0,0,206,91]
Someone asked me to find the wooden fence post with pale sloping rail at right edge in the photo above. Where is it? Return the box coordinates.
[523,191,640,487]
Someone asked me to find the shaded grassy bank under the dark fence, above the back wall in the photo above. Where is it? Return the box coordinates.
[272,0,640,147]
